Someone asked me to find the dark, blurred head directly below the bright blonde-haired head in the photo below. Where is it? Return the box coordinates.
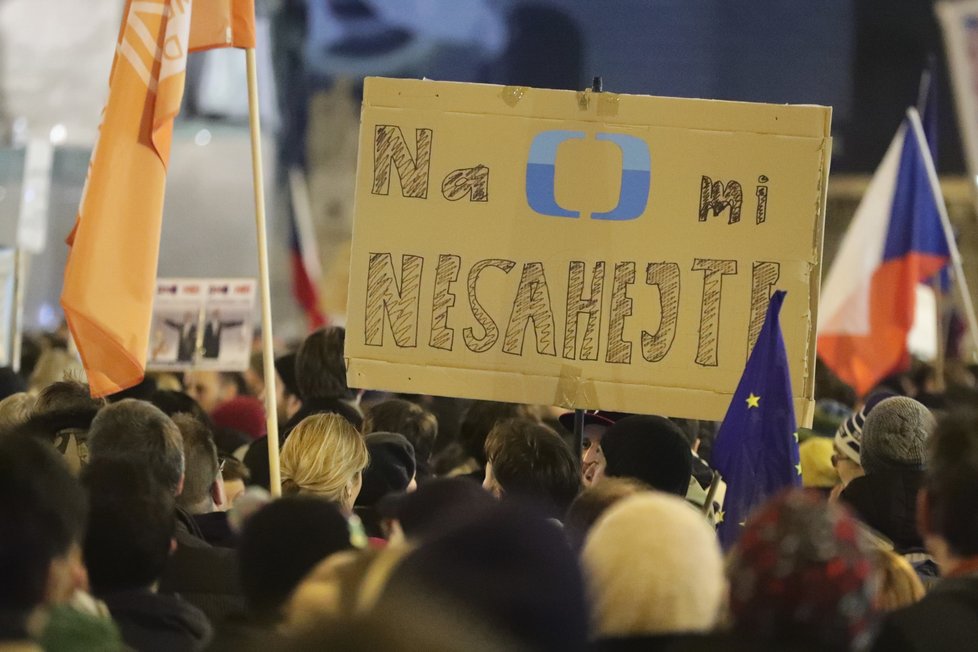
[238,496,352,617]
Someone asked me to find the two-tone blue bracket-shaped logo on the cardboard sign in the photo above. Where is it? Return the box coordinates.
[526,129,652,221]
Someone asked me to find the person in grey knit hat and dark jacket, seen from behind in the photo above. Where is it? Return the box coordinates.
[840,396,935,554]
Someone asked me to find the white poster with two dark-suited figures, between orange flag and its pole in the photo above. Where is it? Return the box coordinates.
[146,278,255,371]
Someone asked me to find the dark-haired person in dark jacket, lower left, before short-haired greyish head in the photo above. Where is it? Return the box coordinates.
[83,459,212,652]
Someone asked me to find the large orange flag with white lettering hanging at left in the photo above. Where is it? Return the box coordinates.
[61,0,255,396]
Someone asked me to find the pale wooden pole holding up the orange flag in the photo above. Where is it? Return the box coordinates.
[245,48,282,498]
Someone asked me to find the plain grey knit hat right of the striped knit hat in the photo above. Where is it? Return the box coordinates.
[861,396,937,473]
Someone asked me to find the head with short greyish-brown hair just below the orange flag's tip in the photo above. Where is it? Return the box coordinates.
[88,399,184,496]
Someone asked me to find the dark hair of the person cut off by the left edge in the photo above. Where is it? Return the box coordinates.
[0,435,86,617]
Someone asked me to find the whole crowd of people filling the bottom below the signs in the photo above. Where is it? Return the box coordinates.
[0,327,978,652]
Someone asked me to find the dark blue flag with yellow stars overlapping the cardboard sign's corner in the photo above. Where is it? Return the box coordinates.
[711,290,801,549]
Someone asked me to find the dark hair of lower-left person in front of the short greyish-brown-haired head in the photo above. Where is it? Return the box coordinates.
[82,459,176,594]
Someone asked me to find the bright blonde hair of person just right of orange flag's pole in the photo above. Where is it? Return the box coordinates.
[281,414,370,504]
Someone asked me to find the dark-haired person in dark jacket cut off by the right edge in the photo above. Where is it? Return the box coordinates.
[873,412,978,652]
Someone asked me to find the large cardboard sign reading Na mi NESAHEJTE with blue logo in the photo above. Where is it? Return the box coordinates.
[346,79,831,423]
